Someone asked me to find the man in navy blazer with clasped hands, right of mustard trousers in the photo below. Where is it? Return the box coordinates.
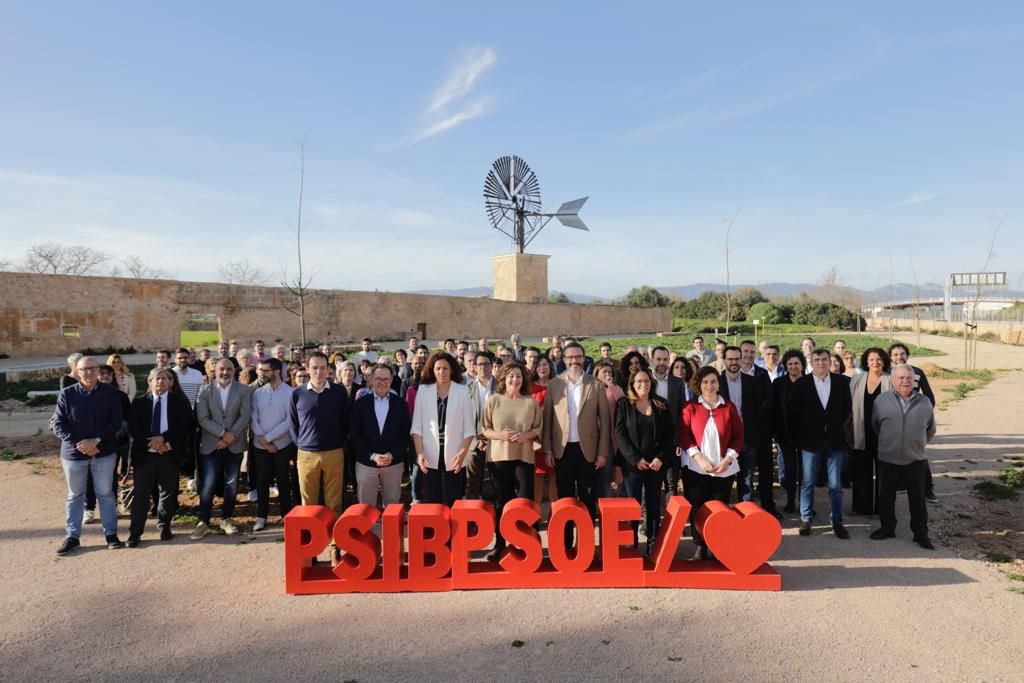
[348,364,412,507]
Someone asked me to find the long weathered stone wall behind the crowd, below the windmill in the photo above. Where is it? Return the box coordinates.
[0,272,672,356]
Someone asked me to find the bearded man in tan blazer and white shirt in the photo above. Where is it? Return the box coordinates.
[542,342,612,548]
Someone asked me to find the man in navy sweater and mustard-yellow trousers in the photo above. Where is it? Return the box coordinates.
[292,351,349,515]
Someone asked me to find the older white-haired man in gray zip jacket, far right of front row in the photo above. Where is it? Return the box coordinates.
[871,364,935,550]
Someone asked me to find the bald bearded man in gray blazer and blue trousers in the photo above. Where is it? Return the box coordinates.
[189,358,252,541]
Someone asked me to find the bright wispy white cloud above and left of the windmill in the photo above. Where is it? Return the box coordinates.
[411,47,498,144]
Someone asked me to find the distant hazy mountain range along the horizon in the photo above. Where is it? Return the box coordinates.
[410,283,1017,304]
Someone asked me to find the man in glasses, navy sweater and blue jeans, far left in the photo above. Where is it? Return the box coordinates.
[53,356,123,555]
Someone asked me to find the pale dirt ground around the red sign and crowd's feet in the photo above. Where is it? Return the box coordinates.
[0,373,1024,681]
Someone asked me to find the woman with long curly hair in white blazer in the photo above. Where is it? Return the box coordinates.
[411,351,476,507]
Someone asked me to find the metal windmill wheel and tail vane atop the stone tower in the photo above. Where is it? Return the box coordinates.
[483,155,590,254]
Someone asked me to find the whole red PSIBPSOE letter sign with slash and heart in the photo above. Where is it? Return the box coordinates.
[285,496,782,595]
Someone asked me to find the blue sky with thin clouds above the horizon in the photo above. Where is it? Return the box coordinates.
[0,1,1024,296]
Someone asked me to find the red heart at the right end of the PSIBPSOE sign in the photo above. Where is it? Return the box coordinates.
[696,501,782,575]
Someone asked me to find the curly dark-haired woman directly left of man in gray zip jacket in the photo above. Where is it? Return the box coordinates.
[850,346,893,515]
